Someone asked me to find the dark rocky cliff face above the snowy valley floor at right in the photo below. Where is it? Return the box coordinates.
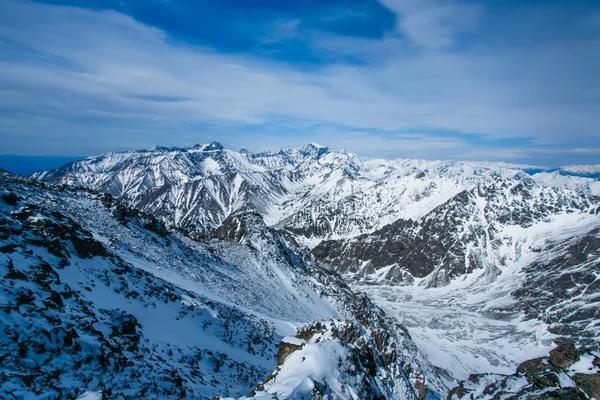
[313,179,600,287]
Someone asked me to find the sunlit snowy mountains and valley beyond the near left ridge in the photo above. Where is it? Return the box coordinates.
[36,143,600,388]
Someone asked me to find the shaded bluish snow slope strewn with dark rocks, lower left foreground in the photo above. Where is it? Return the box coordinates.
[0,187,277,398]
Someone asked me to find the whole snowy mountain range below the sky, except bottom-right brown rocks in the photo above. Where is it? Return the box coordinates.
[0,142,600,399]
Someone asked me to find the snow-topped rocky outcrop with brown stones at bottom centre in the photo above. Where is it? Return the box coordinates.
[250,318,443,400]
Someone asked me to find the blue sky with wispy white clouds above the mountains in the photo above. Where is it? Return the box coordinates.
[0,0,600,166]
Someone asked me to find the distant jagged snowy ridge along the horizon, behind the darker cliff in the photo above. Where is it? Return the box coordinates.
[35,142,600,247]
